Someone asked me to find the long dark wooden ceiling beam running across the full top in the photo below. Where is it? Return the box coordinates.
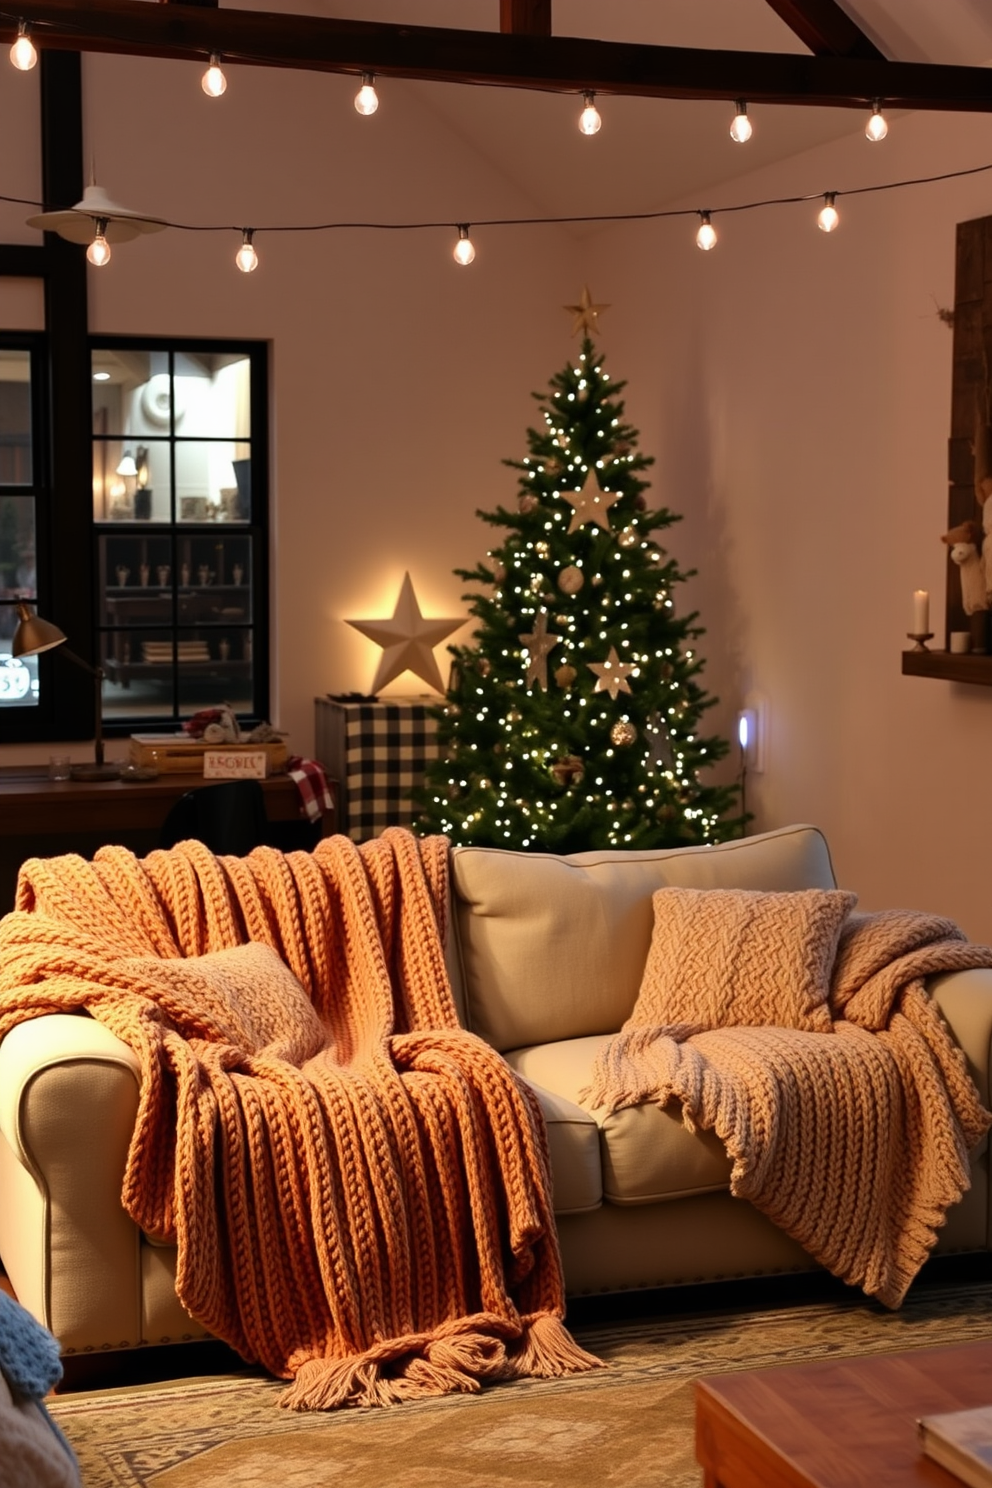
[7,0,992,113]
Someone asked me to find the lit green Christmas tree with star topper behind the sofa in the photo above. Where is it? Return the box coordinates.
[416,292,742,853]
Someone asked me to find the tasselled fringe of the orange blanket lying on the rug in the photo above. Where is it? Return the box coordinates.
[280,1312,604,1411]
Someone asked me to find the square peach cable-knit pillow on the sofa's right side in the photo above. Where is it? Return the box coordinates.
[628,888,857,1033]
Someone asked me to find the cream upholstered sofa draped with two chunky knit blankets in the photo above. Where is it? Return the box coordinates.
[0,826,992,1354]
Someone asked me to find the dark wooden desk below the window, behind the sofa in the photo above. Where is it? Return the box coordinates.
[0,765,335,914]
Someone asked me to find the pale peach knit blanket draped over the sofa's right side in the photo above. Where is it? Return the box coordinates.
[583,911,992,1306]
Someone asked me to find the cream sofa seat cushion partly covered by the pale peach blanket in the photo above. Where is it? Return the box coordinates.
[504,1034,730,1210]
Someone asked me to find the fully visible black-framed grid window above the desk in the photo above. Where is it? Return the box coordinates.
[91,336,269,734]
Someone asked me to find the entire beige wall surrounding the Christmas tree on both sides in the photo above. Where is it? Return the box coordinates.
[0,58,992,939]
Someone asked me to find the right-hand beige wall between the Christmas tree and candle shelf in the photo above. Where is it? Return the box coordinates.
[590,110,992,939]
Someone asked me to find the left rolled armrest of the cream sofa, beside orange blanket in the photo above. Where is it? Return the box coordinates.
[0,1013,141,1351]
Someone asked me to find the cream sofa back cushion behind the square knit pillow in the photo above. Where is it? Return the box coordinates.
[451,826,836,1051]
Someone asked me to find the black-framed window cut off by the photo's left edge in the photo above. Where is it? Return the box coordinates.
[0,332,52,717]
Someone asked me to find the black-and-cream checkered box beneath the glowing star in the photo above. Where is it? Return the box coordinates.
[317,698,440,842]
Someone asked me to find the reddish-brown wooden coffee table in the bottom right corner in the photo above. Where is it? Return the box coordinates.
[696,1341,992,1488]
